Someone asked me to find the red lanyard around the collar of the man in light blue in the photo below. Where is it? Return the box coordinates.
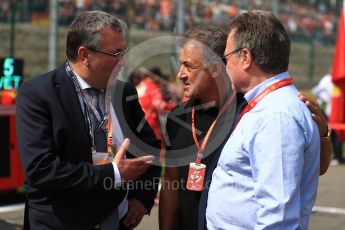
[234,77,292,130]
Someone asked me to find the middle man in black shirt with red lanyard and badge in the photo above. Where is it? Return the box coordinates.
[159,23,330,230]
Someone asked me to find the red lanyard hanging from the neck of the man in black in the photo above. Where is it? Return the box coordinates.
[192,93,236,164]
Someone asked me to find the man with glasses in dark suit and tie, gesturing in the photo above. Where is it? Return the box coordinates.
[17,11,160,229]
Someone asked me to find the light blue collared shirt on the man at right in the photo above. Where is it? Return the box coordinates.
[206,72,320,230]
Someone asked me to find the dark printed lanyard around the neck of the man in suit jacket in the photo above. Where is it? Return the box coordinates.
[65,61,109,148]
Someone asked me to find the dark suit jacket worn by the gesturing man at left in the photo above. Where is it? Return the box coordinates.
[16,67,160,229]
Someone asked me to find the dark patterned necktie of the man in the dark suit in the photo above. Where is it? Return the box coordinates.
[87,88,119,230]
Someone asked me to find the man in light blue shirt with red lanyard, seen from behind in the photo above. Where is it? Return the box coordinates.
[206,11,320,229]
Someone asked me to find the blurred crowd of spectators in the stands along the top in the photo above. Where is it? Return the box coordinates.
[0,0,337,44]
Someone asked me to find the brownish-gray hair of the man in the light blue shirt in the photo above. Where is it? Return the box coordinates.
[230,10,290,74]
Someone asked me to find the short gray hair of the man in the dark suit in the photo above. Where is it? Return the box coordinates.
[66,11,127,60]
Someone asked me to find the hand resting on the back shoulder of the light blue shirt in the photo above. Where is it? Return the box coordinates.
[298,92,328,137]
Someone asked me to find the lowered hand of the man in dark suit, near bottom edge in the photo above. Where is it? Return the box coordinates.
[122,198,147,229]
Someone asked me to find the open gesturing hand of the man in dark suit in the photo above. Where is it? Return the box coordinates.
[114,138,154,182]
